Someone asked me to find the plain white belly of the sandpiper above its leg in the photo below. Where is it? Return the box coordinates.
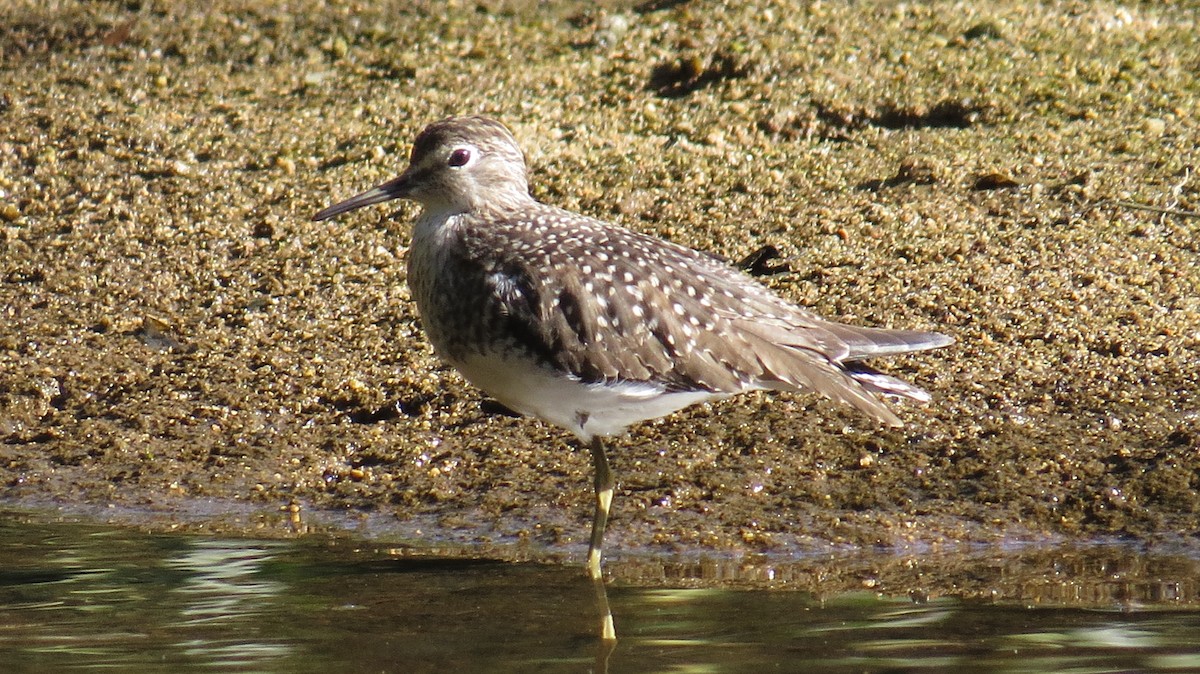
[451,355,730,441]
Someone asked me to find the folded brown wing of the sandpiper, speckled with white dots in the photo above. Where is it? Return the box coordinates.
[470,204,942,425]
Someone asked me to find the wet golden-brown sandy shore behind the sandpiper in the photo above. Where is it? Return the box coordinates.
[0,0,1200,561]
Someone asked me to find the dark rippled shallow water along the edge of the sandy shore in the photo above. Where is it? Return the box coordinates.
[0,511,1200,672]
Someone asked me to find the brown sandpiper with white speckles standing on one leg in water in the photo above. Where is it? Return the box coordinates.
[316,116,953,578]
